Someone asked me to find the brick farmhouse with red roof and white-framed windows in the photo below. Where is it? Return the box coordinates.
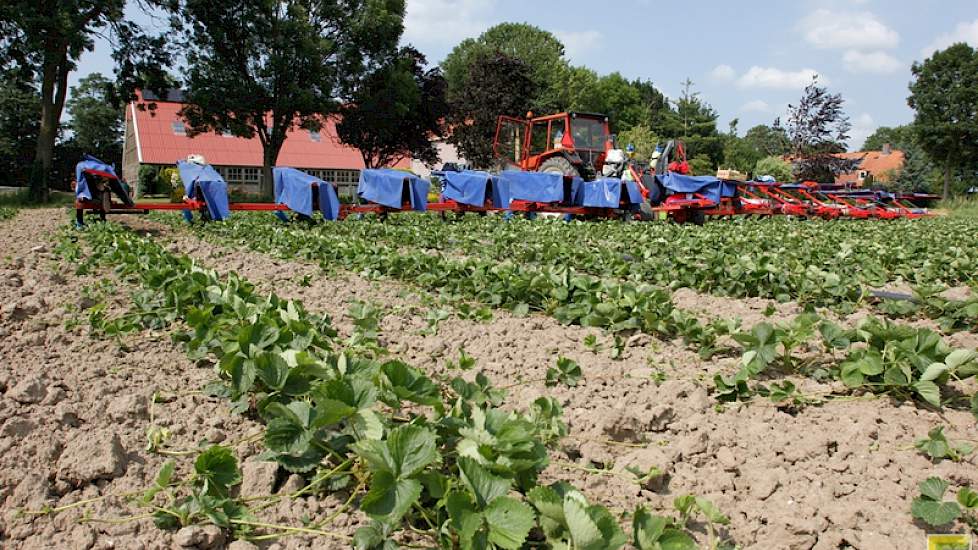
[122,90,409,199]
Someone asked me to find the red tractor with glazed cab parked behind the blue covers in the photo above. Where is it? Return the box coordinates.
[493,113,612,180]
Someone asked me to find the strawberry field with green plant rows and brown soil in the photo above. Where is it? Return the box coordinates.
[0,210,978,550]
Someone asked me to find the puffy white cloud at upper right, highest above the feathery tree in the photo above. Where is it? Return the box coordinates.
[799,9,900,50]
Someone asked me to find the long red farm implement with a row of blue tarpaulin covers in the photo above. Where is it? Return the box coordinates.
[75,149,928,224]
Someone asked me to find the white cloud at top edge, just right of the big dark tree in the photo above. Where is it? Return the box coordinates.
[401,0,497,47]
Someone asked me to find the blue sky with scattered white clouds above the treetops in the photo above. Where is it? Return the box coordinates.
[72,0,978,151]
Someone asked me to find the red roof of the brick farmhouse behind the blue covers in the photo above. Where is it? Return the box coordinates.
[126,91,410,170]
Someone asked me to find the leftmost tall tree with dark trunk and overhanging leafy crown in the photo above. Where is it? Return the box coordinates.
[0,0,170,202]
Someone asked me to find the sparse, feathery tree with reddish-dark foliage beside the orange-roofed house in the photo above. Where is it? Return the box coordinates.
[774,76,855,182]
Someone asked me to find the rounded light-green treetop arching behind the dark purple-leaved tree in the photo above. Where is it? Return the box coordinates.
[441,23,568,113]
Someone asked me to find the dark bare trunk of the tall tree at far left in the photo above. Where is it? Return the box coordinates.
[29,49,68,202]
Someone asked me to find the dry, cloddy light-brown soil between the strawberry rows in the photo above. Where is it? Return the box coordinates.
[0,211,978,550]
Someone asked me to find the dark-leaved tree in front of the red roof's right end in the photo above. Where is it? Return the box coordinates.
[336,47,448,168]
